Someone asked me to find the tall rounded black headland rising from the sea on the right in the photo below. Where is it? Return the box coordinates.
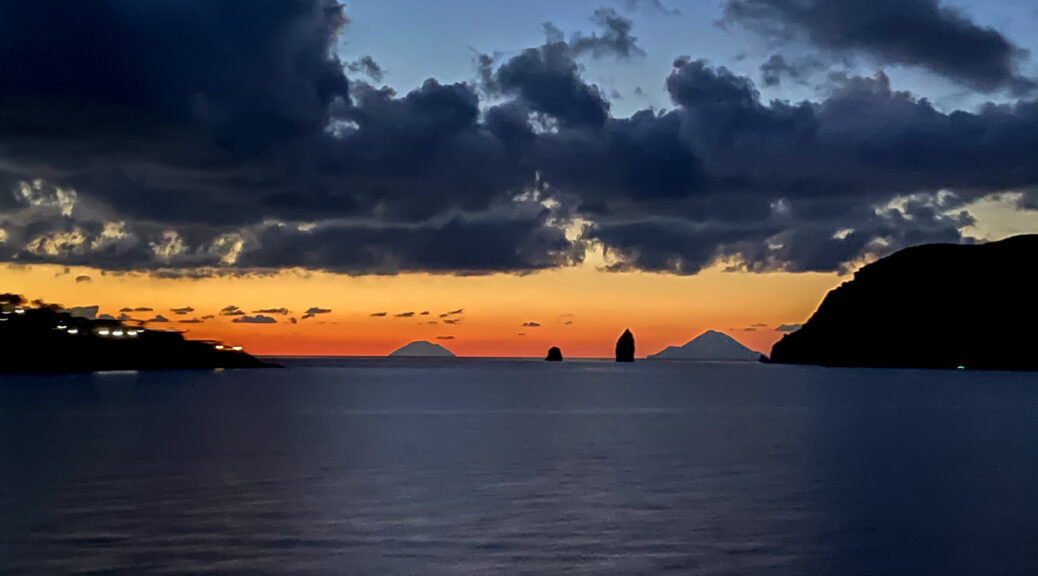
[771,236,1038,371]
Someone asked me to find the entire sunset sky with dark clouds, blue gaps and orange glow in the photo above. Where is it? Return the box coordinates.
[0,0,1038,357]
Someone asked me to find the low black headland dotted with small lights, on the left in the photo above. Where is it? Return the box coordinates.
[0,294,274,373]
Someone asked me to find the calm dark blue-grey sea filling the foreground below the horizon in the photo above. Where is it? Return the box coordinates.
[0,360,1038,576]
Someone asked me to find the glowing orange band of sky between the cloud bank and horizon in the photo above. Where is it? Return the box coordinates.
[0,259,846,357]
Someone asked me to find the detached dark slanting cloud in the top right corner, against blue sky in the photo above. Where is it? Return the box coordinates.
[725,0,1035,91]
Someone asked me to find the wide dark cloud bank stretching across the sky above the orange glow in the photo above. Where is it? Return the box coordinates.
[0,0,1038,280]
